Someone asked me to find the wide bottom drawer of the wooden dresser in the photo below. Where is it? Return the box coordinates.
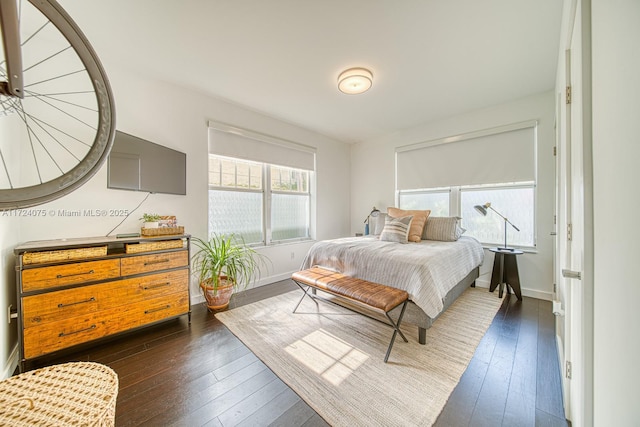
[23,292,189,359]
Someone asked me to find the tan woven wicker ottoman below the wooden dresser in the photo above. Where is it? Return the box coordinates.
[0,362,118,427]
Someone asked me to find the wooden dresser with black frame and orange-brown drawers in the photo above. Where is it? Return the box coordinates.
[15,235,191,370]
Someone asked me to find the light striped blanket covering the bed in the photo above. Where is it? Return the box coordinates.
[301,236,484,318]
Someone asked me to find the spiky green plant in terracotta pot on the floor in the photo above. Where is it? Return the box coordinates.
[192,234,266,310]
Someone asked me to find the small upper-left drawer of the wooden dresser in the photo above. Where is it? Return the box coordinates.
[22,259,120,292]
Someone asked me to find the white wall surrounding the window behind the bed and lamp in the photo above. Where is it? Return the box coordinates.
[351,91,555,300]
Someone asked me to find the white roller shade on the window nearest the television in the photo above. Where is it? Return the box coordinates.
[209,122,315,171]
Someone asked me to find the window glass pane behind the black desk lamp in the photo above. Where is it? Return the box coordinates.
[461,185,535,247]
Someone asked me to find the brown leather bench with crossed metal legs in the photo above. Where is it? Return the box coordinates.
[291,267,409,362]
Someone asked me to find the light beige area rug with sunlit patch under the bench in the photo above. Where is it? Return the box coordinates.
[216,288,502,426]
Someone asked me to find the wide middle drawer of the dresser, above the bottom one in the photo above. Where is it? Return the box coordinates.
[22,269,189,329]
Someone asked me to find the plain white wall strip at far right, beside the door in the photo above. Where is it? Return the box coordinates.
[591,0,640,426]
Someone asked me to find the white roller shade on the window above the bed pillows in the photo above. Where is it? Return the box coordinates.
[396,121,537,190]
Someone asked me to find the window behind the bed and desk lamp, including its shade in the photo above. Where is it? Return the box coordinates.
[395,121,537,248]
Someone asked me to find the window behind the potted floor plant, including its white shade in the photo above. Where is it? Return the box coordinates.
[208,121,316,245]
